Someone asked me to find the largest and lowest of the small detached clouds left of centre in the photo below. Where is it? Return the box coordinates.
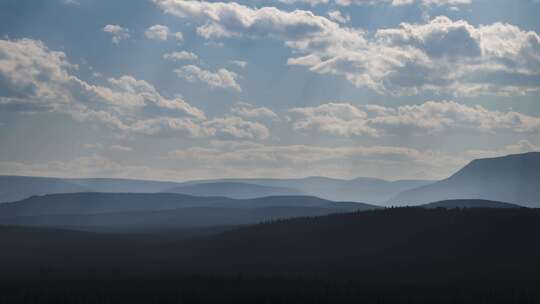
[174,65,242,92]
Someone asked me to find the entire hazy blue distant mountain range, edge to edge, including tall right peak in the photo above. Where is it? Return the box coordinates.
[0,152,540,207]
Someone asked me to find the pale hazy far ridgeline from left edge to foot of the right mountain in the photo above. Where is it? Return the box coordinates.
[0,176,430,204]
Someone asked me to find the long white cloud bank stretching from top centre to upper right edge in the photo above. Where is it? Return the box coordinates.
[154,0,540,96]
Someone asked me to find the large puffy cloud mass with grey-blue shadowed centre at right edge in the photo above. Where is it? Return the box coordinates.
[288,17,540,96]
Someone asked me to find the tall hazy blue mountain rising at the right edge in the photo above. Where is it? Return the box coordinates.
[389,152,540,207]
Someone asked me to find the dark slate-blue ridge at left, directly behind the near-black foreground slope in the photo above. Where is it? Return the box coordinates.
[0,193,378,231]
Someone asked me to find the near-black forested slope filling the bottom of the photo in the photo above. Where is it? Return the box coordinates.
[0,208,540,303]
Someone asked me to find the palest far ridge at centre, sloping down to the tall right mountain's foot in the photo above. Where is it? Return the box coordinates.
[179,176,433,204]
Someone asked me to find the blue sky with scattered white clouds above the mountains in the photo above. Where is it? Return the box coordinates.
[0,0,540,181]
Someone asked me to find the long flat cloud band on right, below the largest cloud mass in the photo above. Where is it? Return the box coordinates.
[289,101,540,137]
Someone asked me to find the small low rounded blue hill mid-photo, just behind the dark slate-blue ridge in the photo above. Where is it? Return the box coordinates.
[163,182,306,199]
